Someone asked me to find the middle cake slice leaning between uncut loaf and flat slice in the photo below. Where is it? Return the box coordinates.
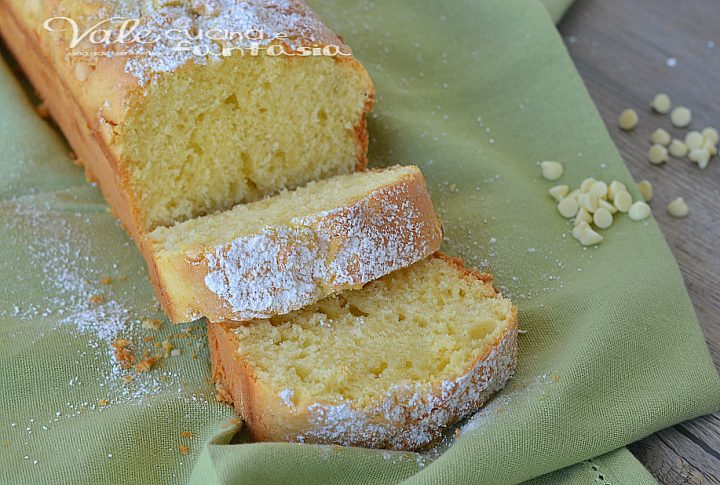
[143,166,442,322]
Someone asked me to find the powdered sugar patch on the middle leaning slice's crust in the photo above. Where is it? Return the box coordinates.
[205,175,440,320]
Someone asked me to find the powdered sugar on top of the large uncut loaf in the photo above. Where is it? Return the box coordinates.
[87,0,342,86]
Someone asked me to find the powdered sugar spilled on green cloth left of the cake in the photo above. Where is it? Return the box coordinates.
[0,199,200,400]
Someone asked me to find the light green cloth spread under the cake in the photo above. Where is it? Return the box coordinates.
[0,0,720,484]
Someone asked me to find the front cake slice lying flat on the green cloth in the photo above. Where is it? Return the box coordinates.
[208,254,518,450]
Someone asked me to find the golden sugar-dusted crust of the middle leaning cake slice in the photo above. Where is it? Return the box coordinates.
[144,169,442,322]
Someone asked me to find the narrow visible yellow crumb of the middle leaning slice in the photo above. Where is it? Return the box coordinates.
[148,166,419,254]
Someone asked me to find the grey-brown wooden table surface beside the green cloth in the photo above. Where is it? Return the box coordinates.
[559,0,720,484]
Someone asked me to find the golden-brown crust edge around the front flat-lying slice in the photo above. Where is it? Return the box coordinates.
[208,253,518,450]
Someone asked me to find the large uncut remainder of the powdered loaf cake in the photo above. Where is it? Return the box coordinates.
[0,0,373,238]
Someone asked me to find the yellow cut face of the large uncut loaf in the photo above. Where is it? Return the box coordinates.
[115,55,371,231]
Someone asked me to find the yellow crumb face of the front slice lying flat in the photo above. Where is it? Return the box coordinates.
[234,257,513,408]
